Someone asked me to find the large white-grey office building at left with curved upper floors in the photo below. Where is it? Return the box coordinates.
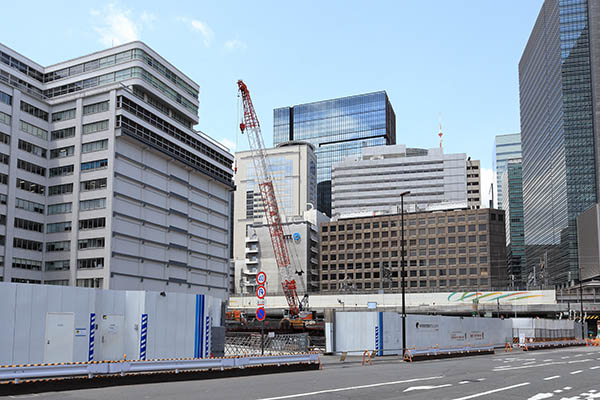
[0,42,233,299]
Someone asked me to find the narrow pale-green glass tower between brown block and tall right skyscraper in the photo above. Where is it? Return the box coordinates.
[499,159,527,287]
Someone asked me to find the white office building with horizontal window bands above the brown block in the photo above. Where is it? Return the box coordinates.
[331,145,467,218]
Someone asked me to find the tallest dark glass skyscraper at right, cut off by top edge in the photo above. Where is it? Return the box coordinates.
[519,0,600,284]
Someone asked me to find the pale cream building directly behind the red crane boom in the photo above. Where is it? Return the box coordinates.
[233,142,319,293]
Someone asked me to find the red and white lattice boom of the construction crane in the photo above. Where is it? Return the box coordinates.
[238,80,300,317]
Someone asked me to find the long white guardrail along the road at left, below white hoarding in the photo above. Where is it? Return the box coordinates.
[0,353,319,383]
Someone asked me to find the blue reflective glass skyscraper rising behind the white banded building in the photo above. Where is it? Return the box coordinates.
[273,91,396,215]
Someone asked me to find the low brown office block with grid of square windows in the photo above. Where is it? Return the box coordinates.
[320,209,506,293]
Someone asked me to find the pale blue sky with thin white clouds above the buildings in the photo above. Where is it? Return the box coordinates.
[0,0,543,204]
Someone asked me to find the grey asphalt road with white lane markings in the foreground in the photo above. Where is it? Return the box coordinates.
[8,347,600,400]
